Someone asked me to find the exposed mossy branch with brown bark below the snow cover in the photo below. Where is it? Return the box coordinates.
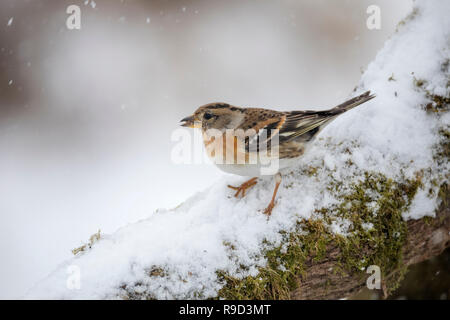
[218,178,450,299]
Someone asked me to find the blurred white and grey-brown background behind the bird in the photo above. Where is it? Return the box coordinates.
[0,0,412,298]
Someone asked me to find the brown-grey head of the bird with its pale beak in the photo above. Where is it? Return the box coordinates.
[181,103,245,131]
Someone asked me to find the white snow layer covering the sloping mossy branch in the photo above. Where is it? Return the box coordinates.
[25,0,450,299]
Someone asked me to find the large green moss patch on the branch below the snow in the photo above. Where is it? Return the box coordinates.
[217,172,421,299]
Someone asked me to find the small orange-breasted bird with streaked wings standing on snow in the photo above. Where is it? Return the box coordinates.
[181,91,375,216]
